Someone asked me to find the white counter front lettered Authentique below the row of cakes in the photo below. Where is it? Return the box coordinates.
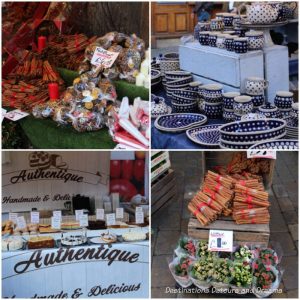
[2,228,149,298]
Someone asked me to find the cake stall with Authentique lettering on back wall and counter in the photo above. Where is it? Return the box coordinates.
[2,151,149,298]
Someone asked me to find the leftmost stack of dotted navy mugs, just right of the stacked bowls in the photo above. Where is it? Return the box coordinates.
[199,83,223,119]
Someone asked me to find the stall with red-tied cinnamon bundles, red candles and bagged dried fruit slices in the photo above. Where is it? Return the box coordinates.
[2,2,149,149]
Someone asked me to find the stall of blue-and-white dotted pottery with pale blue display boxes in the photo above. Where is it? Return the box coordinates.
[151,3,298,149]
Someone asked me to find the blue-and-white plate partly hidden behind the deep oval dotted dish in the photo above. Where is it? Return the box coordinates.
[186,128,220,148]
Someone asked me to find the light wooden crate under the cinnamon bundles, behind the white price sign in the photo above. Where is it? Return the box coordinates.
[188,216,270,247]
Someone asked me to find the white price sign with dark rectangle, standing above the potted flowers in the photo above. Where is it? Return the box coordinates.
[208,230,233,252]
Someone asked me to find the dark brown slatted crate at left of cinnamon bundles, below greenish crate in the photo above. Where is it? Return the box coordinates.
[151,169,177,215]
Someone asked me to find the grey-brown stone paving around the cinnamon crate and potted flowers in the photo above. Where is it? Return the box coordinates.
[152,151,298,298]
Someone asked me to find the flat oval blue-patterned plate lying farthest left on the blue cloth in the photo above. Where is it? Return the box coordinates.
[154,113,207,132]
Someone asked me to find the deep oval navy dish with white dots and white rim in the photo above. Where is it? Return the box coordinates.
[220,119,286,144]
